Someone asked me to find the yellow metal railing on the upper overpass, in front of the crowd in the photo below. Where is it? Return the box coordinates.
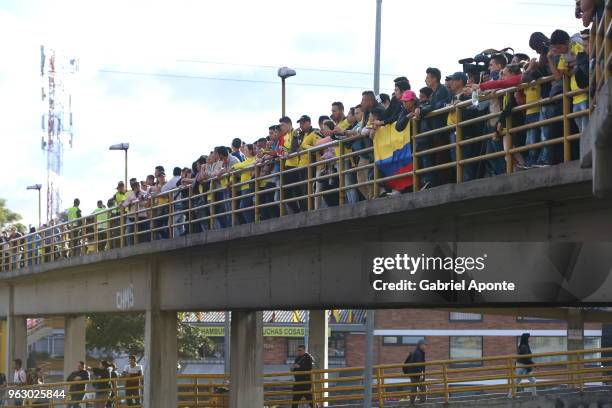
[0,76,589,272]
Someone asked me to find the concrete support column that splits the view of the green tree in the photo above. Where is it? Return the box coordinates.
[144,261,178,408]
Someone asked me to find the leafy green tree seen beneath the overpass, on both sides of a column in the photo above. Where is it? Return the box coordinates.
[87,313,213,359]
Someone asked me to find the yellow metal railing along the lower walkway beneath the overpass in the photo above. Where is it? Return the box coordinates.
[0,348,612,408]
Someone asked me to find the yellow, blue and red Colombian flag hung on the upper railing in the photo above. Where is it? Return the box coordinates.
[374,123,413,190]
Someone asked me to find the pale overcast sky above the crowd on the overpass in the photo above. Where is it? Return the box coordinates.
[0,0,580,224]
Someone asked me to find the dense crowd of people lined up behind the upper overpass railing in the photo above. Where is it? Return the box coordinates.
[0,23,591,264]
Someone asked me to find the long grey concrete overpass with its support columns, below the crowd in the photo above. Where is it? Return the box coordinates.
[0,162,612,408]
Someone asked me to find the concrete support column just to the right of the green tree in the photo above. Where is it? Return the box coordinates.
[230,312,264,408]
